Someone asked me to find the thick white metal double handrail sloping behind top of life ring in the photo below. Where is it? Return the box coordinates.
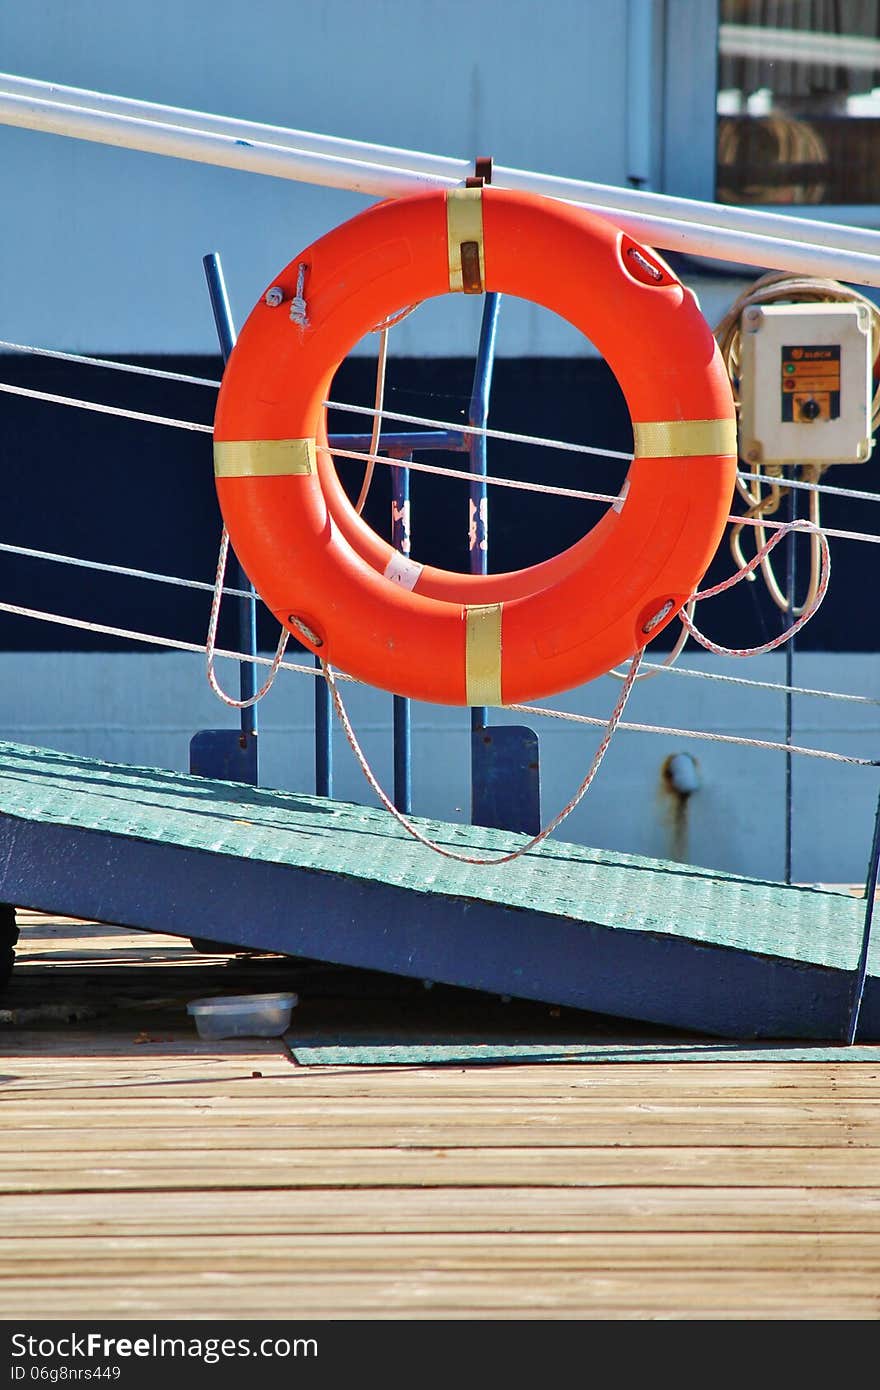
[0,74,880,286]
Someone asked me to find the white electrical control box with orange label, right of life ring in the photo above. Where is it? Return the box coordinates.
[740,303,873,464]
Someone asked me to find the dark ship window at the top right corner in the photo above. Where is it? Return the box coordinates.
[716,0,880,204]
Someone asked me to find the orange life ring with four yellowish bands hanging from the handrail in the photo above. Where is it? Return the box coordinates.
[214,188,737,705]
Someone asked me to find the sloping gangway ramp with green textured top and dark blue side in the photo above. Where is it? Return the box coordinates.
[0,744,880,1041]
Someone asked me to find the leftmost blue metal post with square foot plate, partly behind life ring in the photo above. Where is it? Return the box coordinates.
[189,252,259,787]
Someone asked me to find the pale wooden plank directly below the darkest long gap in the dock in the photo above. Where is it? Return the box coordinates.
[6,1186,880,1248]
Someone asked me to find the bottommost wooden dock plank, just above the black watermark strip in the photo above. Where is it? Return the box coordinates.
[3,1269,880,1321]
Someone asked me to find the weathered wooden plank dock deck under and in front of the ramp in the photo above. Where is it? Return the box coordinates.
[0,913,880,1322]
